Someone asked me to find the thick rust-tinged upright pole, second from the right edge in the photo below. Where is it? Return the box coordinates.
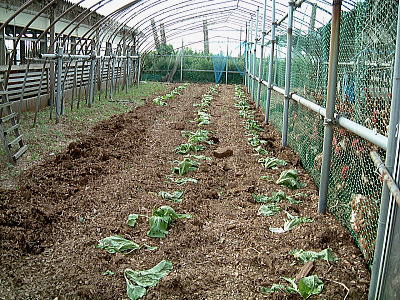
[318,0,342,214]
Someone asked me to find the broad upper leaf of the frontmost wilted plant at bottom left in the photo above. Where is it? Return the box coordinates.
[124,260,173,288]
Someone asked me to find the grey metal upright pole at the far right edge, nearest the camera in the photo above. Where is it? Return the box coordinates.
[368,2,400,300]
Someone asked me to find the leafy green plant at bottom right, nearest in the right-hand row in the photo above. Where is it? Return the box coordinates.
[261,275,324,299]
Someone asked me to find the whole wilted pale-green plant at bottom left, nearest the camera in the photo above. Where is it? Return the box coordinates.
[124,260,173,300]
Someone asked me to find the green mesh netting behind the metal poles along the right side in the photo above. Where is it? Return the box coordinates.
[248,0,398,264]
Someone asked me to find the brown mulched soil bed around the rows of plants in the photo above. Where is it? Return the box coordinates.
[0,84,370,299]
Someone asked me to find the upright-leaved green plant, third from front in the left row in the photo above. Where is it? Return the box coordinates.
[147,206,192,238]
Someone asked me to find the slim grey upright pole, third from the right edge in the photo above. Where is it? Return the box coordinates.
[282,0,295,147]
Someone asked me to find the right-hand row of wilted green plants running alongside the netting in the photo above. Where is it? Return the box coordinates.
[234,86,338,299]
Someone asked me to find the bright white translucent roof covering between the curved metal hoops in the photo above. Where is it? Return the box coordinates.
[2,0,363,53]
